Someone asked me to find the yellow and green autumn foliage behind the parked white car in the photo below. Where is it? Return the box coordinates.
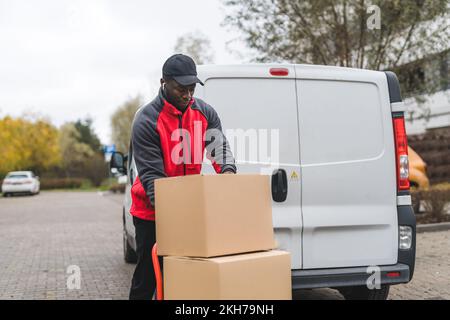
[0,116,108,189]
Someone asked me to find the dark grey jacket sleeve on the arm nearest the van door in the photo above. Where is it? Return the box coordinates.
[205,106,236,173]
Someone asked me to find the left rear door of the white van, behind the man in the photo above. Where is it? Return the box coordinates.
[198,65,302,269]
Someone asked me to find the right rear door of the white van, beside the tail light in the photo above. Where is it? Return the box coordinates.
[296,65,398,269]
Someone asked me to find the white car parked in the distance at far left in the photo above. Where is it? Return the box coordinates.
[2,171,40,197]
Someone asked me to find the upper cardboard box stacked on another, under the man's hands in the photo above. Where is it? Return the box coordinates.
[155,174,275,257]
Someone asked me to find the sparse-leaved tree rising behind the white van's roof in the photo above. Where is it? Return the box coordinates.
[223,0,449,70]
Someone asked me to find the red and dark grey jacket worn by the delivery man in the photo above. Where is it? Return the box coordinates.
[130,90,236,220]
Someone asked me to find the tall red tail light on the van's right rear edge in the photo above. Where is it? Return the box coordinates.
[393,114,409,191]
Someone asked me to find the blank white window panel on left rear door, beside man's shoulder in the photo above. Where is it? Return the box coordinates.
[205,78,299,164]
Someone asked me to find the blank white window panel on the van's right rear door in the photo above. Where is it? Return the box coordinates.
[297,80,383,165]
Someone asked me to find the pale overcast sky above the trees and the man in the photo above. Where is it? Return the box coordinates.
[0,0,250,143]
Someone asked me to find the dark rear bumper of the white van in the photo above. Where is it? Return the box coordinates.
[292,263,411,290]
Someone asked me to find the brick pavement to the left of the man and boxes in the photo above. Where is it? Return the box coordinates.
[0,192,134,299]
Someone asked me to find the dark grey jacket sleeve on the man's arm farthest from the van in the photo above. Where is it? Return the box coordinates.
[131,109,166,207]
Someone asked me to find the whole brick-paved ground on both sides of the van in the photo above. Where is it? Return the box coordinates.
[0,192,450,300]
